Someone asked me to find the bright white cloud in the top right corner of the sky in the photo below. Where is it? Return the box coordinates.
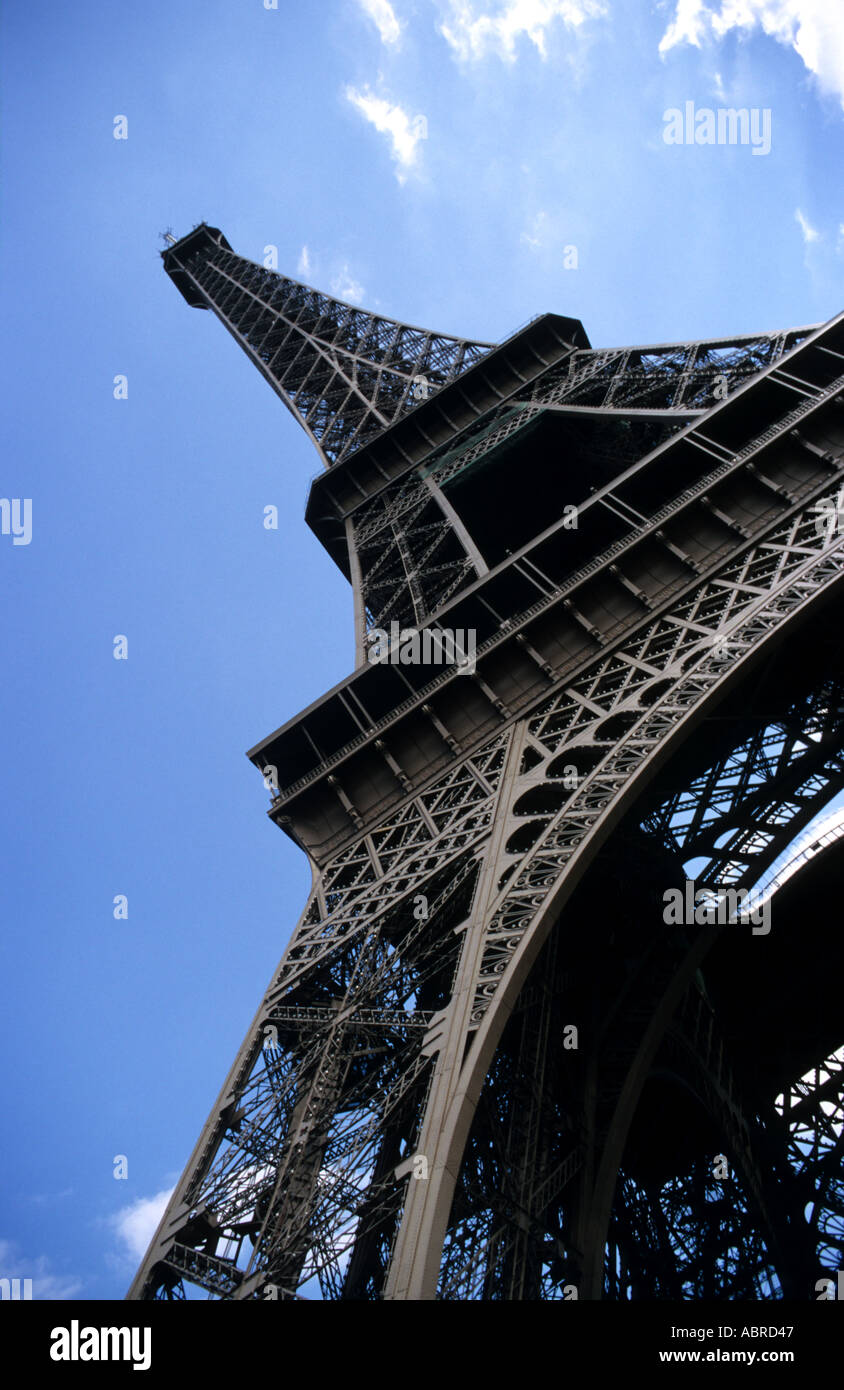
[659,0,844,107]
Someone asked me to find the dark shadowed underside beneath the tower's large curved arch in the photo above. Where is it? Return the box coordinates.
[438,614,844,1300]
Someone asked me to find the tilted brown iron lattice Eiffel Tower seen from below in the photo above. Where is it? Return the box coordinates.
[128,222,844,1301]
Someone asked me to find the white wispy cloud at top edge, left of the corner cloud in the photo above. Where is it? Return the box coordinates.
[439,0,606,63]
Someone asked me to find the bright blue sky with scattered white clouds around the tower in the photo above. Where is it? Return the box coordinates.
[0,0,844,1298]
